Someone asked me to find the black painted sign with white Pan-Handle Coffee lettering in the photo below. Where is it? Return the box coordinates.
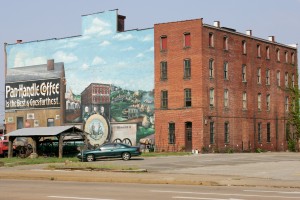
[5,79,60,110]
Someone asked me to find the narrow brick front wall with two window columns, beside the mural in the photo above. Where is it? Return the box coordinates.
[154,19,203,151]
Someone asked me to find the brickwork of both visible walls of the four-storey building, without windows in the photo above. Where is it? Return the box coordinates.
[154,20,298,151]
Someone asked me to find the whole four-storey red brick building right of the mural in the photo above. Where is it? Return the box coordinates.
[154,19,298,152]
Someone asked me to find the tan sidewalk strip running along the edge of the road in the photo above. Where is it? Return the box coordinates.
[0,162,300,188]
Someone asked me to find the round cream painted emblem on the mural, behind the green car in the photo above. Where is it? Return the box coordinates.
[84,114,109,146]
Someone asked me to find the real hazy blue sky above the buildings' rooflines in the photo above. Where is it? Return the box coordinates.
[0,0,300,121]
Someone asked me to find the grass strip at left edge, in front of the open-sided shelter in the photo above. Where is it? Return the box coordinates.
[0,157,79,167]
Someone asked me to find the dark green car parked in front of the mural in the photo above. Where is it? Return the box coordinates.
[77,143,141,162]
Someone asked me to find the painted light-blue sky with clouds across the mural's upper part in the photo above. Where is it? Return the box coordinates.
[7,10,154,94]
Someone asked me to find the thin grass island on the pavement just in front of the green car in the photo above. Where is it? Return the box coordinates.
[48,161,138,171]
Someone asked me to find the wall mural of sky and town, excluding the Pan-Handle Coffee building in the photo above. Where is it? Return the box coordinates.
[6,10,154,146]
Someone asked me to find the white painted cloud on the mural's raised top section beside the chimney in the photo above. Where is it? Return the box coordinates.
[84,18,111,35]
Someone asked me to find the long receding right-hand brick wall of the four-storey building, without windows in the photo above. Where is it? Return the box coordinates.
[202,27,297,151]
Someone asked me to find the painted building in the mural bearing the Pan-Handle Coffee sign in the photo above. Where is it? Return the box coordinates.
[5,59,66,133]
